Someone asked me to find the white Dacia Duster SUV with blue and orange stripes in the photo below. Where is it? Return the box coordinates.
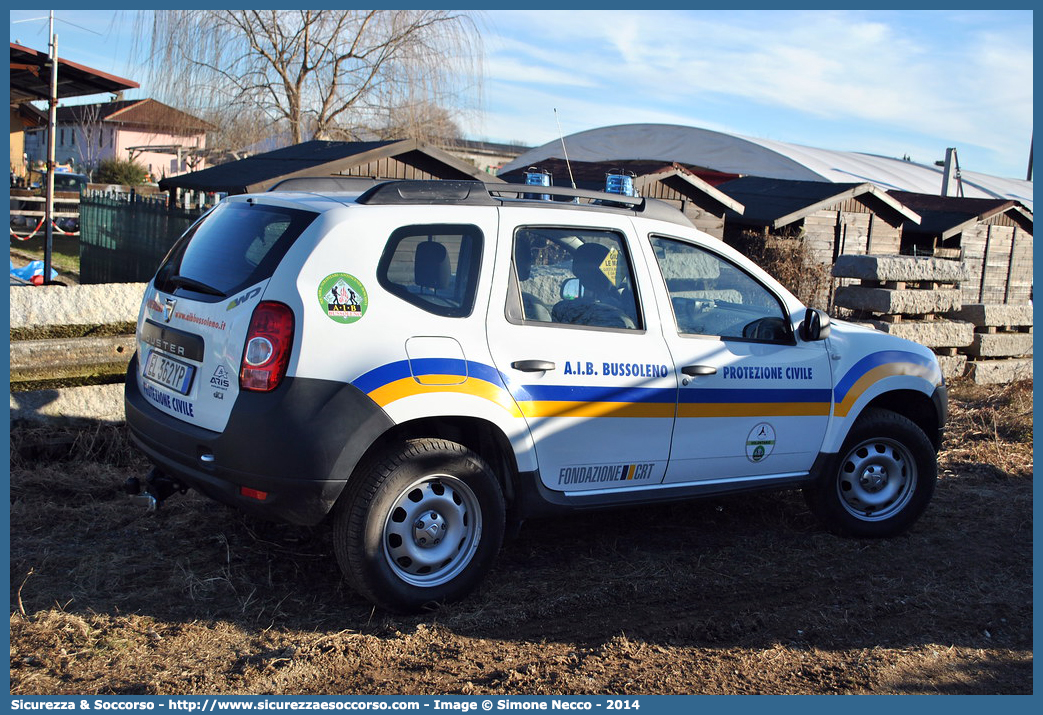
[126,180,946,611]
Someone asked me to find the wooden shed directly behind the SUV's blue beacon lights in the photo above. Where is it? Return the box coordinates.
[500,158,745,239]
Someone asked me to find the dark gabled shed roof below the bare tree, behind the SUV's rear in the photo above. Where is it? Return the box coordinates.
[160,140,496,194]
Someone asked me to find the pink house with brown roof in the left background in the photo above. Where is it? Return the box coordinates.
[26,99,216,181]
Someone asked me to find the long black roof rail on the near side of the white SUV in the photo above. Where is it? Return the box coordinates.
[356,180,693,226]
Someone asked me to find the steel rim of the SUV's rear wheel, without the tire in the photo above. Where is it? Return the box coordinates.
[383,474,482,588]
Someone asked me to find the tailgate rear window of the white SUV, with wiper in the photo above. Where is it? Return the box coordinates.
[155,202,318,297]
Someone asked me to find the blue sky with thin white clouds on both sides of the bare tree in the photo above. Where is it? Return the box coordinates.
[10,9,1033,178]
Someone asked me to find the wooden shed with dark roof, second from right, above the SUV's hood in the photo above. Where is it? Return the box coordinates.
[718,176,920,265]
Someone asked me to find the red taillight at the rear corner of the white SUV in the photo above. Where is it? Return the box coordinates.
[239,301,293,392]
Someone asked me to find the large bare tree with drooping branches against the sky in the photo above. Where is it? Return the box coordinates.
[137,9,481,143]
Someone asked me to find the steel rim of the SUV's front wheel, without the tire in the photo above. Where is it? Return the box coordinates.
[836,438,918,521]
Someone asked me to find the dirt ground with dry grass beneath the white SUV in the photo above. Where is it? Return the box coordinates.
[10,384,1033,694]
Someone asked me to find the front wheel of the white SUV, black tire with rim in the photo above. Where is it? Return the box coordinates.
[804,410,938,538]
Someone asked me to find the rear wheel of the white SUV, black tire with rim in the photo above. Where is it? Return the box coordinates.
[334,439,506,613]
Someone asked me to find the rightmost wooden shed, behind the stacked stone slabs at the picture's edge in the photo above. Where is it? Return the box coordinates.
[890,191,1033,304]
